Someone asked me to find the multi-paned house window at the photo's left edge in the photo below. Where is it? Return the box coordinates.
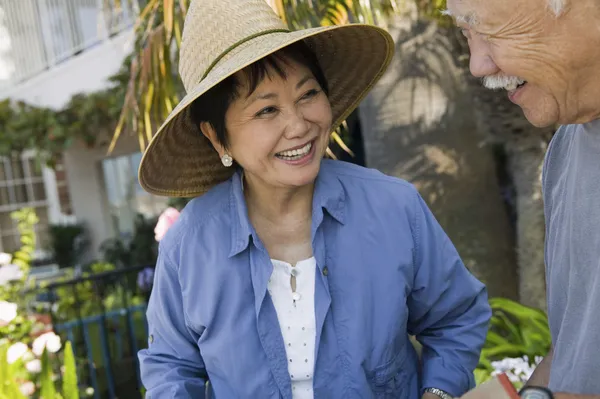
[0,155,49,252]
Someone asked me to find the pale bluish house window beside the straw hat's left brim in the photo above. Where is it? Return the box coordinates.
[101,152,168,234]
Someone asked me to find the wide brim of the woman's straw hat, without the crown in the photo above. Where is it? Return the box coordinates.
[138,24,394,197]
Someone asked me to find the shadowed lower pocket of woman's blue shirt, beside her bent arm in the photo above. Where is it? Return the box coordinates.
[369,351,410,399]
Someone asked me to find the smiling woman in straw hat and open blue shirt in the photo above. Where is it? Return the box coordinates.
[139,0,490,399]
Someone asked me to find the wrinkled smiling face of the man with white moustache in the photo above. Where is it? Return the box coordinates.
[447,0,599,127]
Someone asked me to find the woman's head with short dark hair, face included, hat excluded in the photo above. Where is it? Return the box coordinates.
[190,42,333,191]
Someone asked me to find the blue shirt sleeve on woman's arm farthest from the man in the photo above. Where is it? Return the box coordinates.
[139,248,207,399]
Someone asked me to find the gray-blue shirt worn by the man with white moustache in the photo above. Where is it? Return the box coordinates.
[542,120,600,394]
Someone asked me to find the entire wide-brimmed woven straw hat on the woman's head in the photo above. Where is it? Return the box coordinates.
[139,0,394,197]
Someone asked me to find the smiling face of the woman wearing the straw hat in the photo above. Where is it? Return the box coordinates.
[203,59,332,192]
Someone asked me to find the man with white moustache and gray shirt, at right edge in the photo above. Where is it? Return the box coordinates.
[447,0,600,399]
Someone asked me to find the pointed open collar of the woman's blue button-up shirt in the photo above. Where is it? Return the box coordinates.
[229,160,346,257]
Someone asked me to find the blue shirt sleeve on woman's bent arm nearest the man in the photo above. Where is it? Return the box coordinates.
[407,189,491,397]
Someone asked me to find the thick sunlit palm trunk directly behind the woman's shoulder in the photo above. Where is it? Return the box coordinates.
[360,20,518,299]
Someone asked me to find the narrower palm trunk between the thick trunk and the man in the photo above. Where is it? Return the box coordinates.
[470,39,554,310]
